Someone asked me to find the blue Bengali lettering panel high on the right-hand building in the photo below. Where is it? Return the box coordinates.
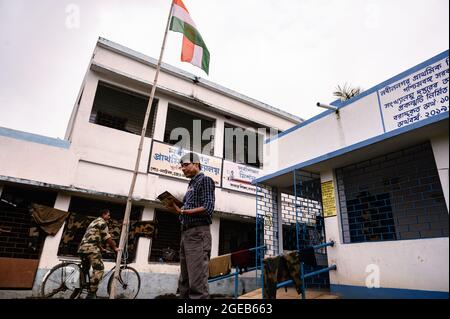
[378,57,449,132]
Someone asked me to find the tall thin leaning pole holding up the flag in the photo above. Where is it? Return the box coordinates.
[109,1,173,299]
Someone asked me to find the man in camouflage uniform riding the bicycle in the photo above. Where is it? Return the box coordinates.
[78,209,118,299]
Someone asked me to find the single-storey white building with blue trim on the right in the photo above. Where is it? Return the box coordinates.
[255,51,449,298]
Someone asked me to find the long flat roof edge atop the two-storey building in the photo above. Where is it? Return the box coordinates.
[97,37,304,124]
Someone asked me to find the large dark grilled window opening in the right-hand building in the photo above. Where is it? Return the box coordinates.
[336,143,448,243]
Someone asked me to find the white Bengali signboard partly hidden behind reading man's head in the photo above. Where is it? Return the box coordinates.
[148,141,222,187]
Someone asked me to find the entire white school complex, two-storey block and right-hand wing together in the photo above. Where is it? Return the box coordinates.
[0,38,449,298]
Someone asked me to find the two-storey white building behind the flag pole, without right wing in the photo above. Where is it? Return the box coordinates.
[0,38,302,298]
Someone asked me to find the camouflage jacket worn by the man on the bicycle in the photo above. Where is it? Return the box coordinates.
[78,217,111,254]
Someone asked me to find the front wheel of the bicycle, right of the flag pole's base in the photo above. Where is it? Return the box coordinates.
[108,266,141,299]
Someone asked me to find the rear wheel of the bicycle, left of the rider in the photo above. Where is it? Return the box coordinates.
[41,263,84,299]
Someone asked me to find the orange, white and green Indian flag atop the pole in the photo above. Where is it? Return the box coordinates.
[170,0,209,74]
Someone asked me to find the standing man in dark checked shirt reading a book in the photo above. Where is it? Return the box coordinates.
[172,153,215,299]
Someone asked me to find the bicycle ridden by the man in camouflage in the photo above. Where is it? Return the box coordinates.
[41,252,141,299]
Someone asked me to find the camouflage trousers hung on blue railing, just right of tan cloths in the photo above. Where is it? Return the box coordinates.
[263,251,302,299]
